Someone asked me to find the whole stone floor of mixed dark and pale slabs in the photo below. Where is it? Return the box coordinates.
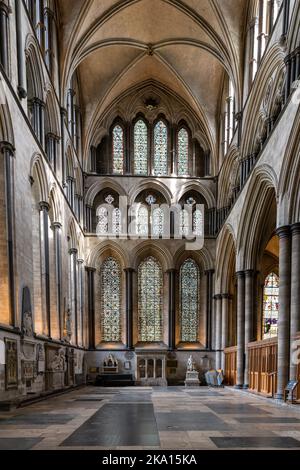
[0,387,300,450]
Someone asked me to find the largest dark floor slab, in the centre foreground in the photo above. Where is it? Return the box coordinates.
[61,403,160,447]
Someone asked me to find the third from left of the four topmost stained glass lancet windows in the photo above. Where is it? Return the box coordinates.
[154,121,168,176]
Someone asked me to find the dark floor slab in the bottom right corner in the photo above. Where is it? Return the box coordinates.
[210,436,300,449]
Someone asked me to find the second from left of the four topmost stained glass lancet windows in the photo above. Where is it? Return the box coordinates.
[134,119,148,175]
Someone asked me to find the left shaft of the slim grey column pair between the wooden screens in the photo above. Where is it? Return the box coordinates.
[236,271,245,388]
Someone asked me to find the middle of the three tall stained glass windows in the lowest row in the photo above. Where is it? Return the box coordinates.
[138,256,163,341]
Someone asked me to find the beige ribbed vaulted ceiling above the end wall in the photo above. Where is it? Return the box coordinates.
[59,0,249,160]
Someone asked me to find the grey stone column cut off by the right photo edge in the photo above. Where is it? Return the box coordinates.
[290,222,300,380]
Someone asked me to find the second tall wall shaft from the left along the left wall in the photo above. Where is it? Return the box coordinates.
[40,201,51,338]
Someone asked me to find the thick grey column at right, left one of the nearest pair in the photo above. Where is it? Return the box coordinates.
[275,226,291,399]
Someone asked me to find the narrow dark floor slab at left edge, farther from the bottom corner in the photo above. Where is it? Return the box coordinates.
[0,413,76,426]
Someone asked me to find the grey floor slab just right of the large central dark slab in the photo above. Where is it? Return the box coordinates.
[156,411,231,431]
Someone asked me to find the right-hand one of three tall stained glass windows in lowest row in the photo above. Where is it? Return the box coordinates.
[180,259,200,343]
